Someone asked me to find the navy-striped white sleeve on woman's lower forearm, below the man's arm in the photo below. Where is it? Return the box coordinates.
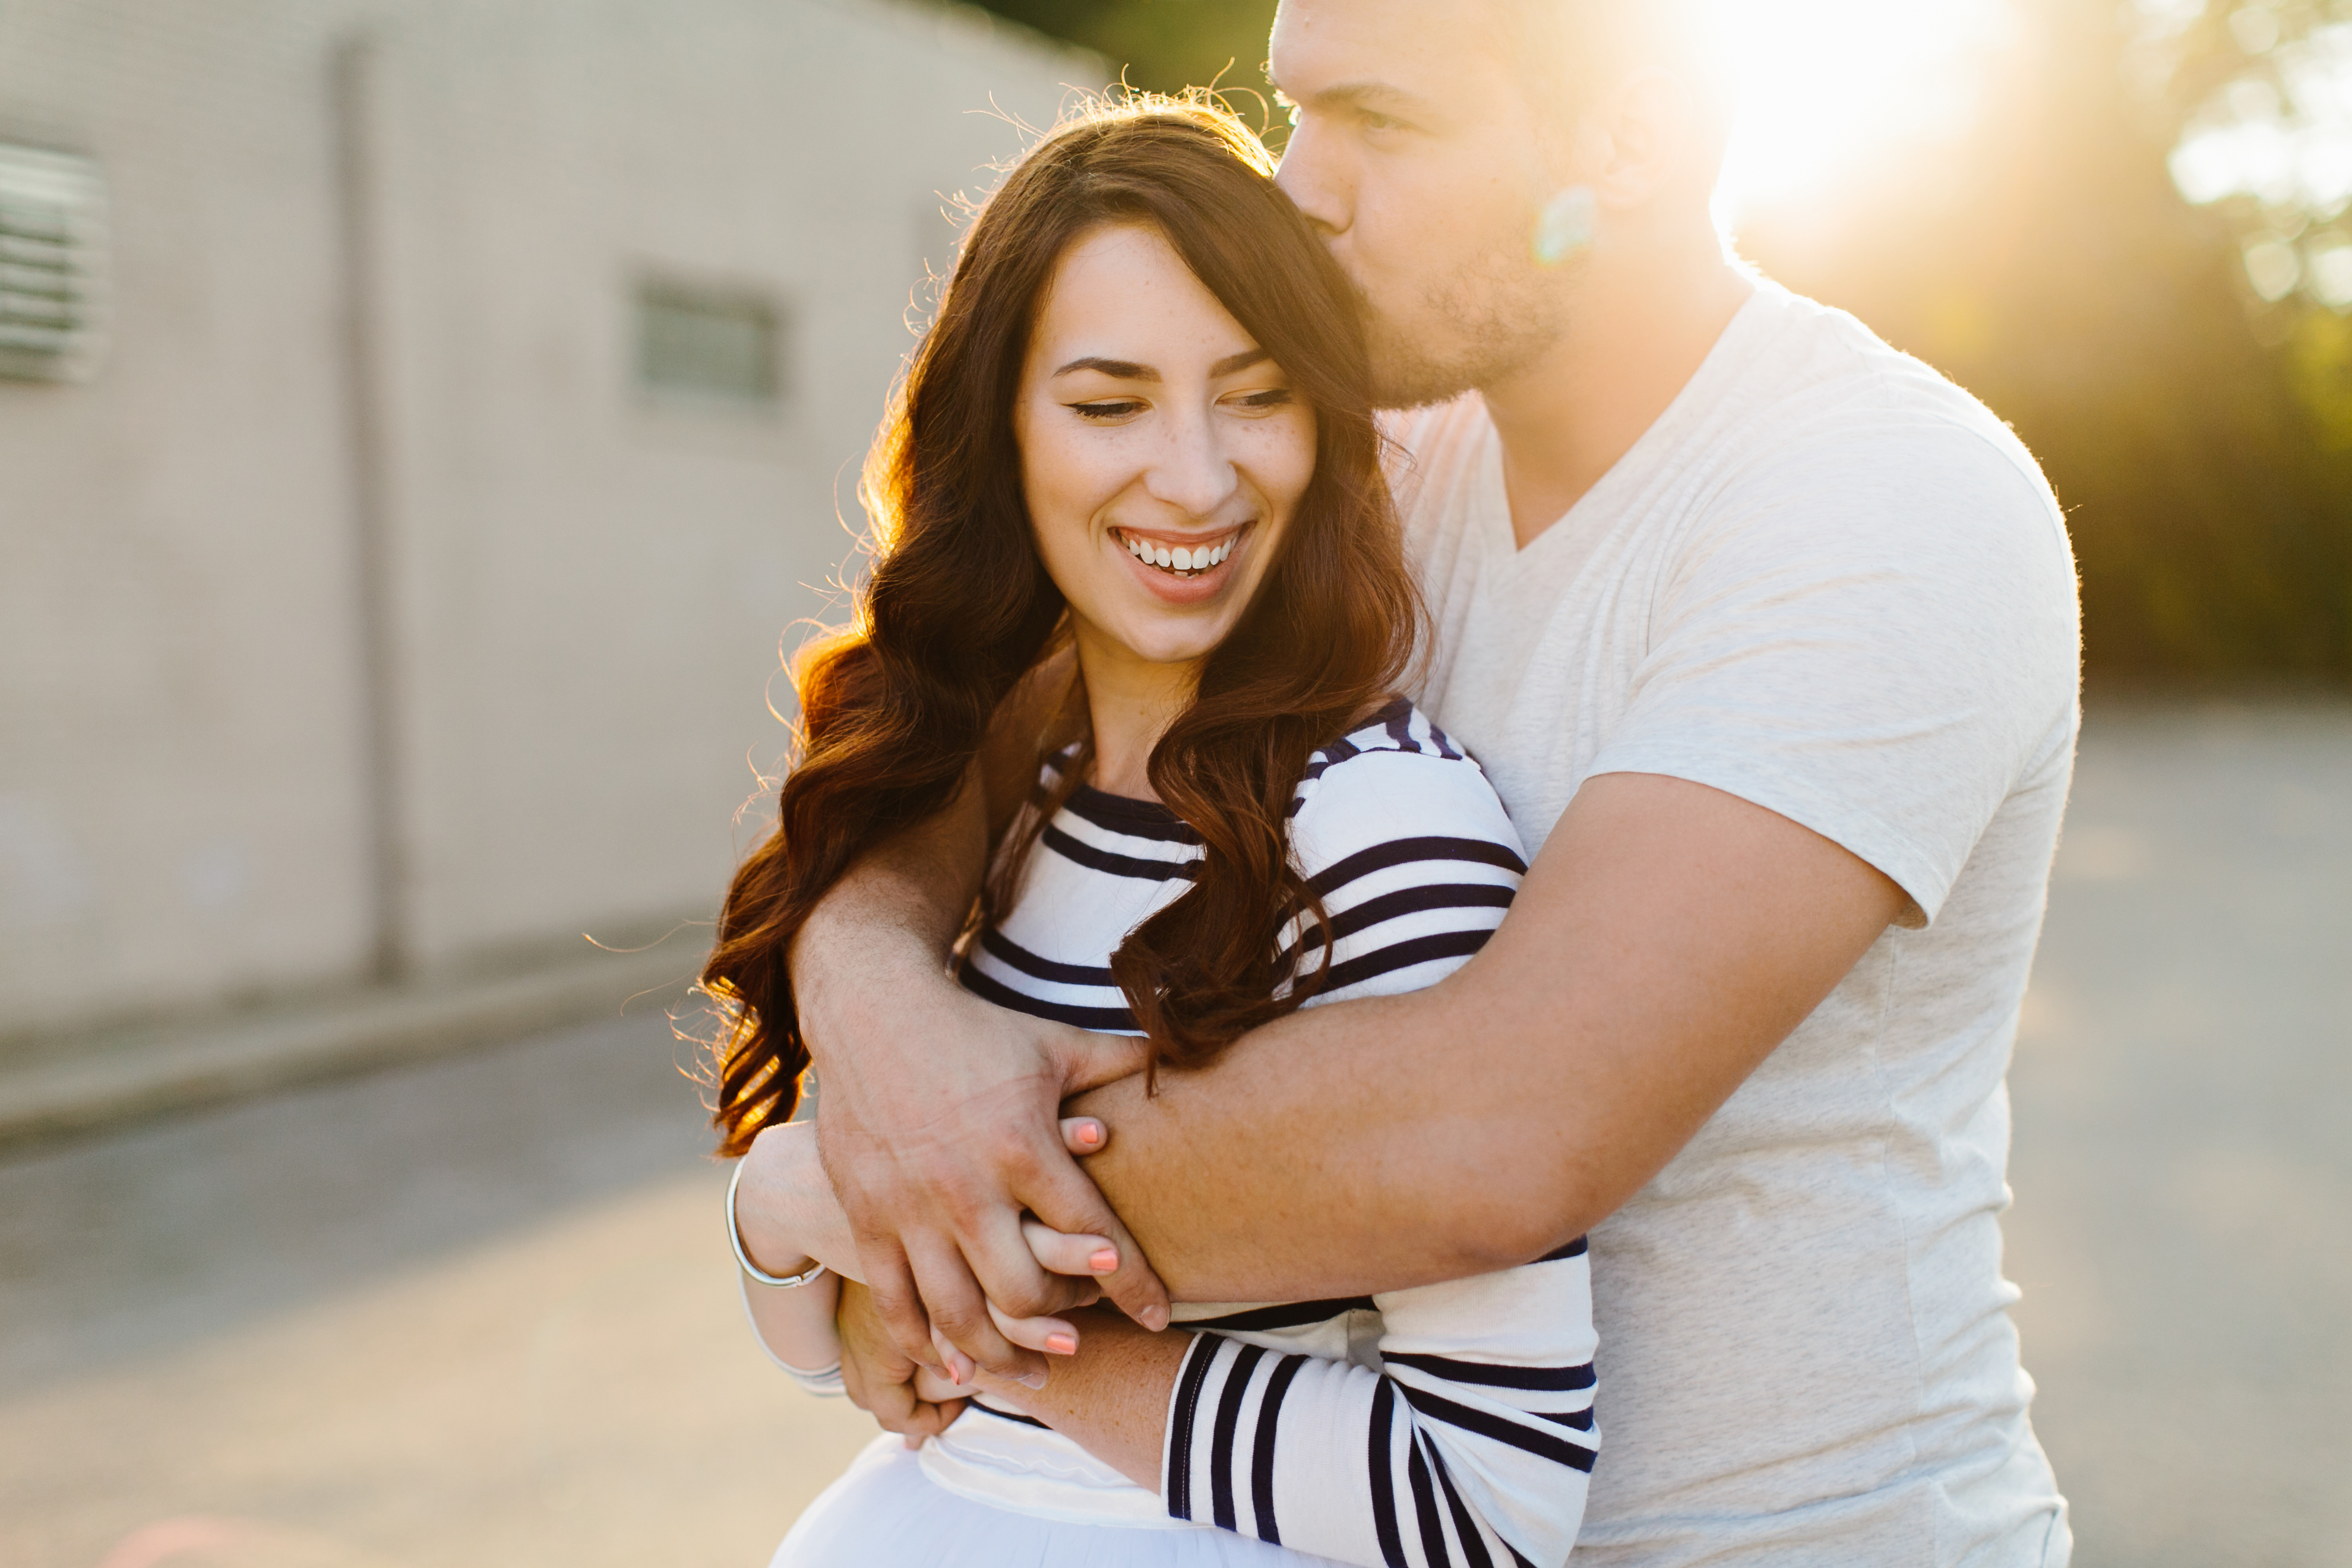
[1162,1241,1599,1568]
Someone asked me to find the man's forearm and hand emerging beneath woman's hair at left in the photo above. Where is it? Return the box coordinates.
[738,656,1166,1377]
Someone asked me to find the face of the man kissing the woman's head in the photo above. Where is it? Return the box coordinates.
[1272,0,1576,407]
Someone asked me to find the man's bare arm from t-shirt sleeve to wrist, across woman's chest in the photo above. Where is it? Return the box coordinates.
[1073,773,1910,1300]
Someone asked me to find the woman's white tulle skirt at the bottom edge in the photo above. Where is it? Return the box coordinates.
[772,1415,1331,1568]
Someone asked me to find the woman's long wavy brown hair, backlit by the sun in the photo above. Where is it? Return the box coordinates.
[703,99,1421,1154]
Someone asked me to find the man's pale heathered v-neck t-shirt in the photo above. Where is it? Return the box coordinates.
[1395,284,2079,1568]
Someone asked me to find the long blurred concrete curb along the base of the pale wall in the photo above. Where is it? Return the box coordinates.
[0,947,701,1154]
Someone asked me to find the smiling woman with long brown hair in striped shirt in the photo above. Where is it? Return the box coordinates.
[706,101,1597,1566]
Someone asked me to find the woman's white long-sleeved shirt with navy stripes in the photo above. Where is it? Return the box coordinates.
[950,700,1599,1568]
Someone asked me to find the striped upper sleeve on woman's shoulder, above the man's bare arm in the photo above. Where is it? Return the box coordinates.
[1284,747,1526,1004]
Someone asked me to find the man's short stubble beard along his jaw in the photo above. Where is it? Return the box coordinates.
[1355,239,1580,409]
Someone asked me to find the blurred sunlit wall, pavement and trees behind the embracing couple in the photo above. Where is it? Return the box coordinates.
[0,0,2352,1568]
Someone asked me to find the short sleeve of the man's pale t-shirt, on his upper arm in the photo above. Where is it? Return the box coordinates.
[1585,421,2079,922]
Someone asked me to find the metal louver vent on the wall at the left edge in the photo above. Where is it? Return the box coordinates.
[0,143,106,381]
